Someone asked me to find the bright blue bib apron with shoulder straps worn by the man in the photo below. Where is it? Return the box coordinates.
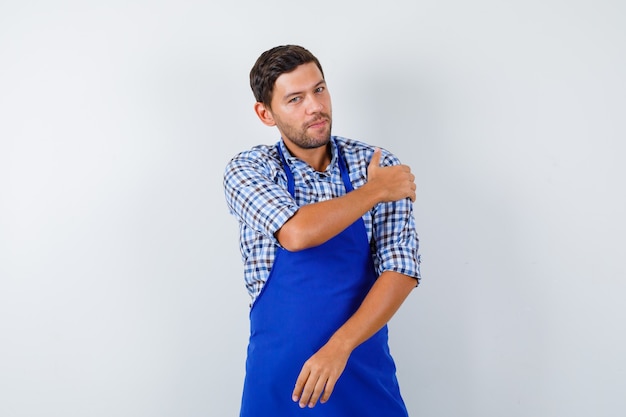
[240,141,408,417]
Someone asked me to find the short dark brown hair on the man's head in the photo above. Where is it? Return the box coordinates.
[250,45,324,107]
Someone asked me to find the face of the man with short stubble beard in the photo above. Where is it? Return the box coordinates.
[270,62,332,149]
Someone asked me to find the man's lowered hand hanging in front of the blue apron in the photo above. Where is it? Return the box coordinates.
[292,342,351,408]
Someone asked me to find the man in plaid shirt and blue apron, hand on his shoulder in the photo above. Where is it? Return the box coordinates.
[224,45,420,417]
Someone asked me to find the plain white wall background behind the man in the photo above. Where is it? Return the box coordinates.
[0,0,626,417]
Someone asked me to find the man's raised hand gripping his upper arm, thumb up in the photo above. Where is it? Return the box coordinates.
[367,148,415,202]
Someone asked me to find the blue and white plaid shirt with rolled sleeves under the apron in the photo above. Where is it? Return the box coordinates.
[224,136,420,303]
